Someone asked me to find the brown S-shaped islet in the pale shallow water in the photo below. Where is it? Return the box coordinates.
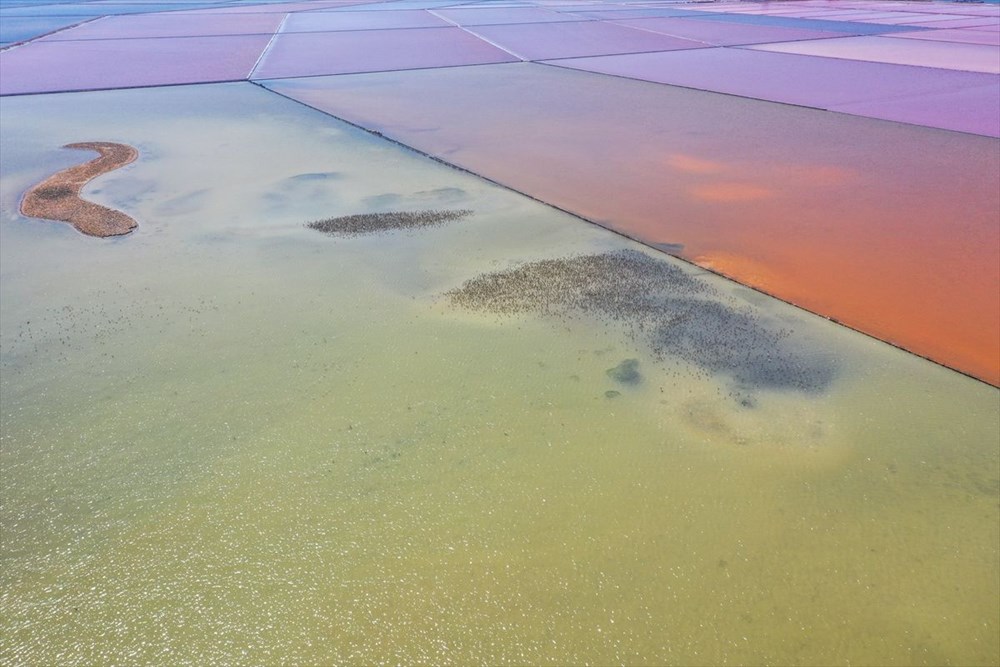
[21,141,139,237]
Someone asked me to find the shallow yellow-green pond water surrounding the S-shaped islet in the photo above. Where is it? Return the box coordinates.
[0,84,1000,665]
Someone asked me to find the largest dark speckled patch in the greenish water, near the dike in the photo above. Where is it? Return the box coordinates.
[447,250,837,393]
